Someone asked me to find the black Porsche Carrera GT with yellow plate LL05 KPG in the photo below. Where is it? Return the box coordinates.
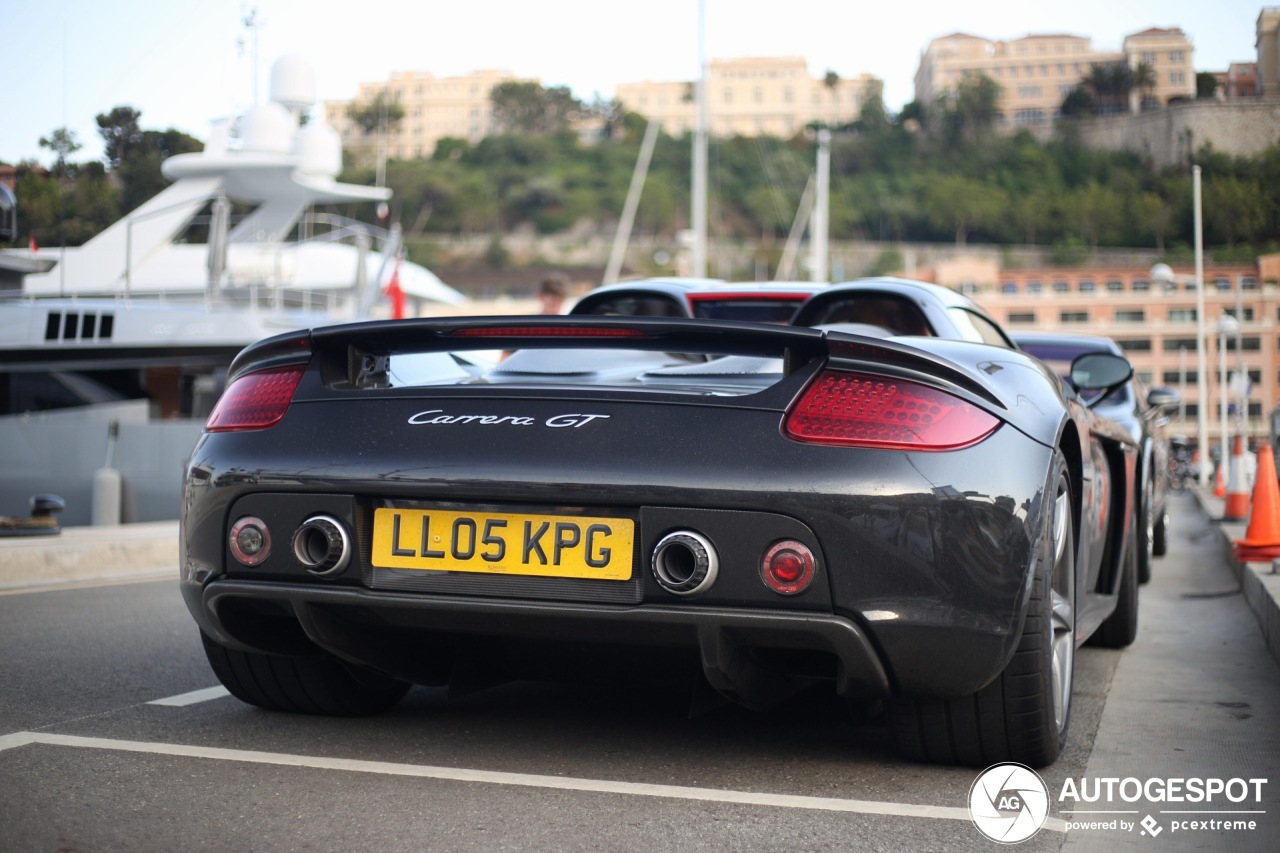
[182,279,1137,766]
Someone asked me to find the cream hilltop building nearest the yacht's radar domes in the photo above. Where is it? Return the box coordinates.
[324,70,536,160]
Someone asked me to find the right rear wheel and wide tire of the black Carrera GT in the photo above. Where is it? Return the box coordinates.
[888,451,1075,767]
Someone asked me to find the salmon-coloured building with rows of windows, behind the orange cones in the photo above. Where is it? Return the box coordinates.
[967,255,1280,442]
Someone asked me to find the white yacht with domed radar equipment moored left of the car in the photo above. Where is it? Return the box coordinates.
[0,56,465,525]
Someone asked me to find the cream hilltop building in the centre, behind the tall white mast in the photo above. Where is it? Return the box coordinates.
[616,56,884,137]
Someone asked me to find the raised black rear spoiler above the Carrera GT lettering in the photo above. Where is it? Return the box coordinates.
[228,315,1002,407]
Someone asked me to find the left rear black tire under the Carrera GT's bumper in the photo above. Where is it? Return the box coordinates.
[200,631,410,717]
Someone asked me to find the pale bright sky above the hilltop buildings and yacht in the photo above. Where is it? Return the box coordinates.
[0,0,1268,165]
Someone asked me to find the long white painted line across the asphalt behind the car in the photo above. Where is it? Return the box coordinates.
[0,731,1066,833]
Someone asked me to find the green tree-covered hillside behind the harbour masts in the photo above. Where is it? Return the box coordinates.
[7,78,1280,275]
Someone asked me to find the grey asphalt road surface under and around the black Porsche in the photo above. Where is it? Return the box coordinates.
[0,497,1280,853]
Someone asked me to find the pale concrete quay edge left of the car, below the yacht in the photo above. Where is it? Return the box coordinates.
[0,521,178,590]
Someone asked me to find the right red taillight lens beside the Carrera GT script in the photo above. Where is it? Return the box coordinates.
[782,370,1000,451]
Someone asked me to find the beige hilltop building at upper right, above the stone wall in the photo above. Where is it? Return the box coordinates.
[915,28,1196,127]
